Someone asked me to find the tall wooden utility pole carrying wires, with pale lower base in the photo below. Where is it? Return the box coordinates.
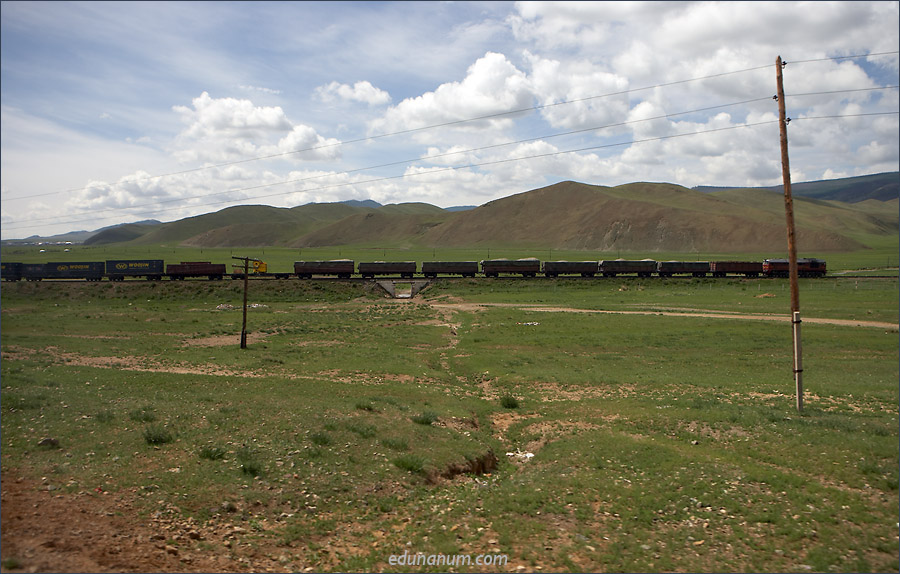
[775,56,803,411]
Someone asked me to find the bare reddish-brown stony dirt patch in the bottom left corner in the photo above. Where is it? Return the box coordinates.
[0,472,288,572]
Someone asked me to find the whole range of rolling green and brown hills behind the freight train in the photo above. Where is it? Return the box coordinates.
[79,181,900,253]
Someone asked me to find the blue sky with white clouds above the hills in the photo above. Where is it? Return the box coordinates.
[0,1,900,239]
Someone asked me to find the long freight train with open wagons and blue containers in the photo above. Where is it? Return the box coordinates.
[0,257,827,281]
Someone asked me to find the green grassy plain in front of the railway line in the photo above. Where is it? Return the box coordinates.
[0,274,900,572]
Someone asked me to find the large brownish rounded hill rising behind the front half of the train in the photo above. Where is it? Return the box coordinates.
[423,182,876,252]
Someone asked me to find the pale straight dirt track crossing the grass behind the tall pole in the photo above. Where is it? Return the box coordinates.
[431,303,900,330]
